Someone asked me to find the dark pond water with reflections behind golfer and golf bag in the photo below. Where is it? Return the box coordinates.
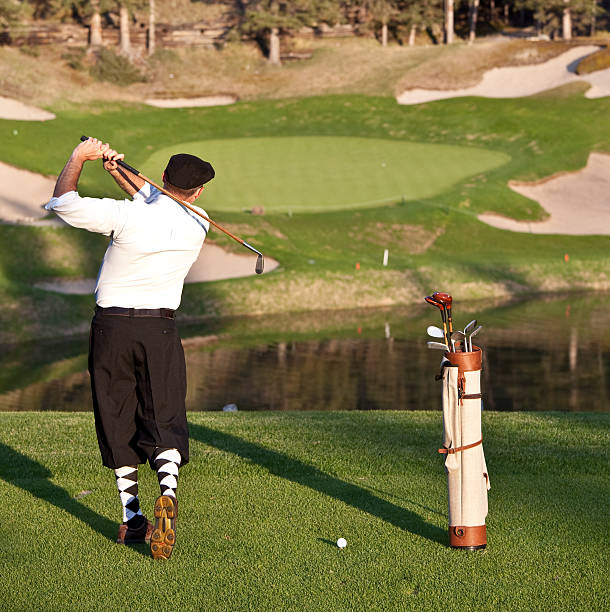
[0,295,610,412]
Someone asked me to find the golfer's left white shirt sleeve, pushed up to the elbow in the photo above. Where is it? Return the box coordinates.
[45,191,130,236]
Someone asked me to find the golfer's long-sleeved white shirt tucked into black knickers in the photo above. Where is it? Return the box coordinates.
[45,183,209,310]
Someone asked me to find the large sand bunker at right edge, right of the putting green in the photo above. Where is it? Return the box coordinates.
[479,153,610,235]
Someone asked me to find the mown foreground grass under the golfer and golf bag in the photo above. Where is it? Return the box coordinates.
[0,412,610,611]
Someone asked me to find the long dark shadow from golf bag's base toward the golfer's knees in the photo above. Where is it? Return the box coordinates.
[189,423,447,544]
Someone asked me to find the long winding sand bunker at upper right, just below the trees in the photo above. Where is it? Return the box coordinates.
[397,46,610,104]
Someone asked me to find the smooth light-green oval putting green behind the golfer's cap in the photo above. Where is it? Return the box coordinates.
[142,136,510,212]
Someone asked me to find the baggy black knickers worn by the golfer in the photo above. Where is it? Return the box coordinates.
[89,312,189,468]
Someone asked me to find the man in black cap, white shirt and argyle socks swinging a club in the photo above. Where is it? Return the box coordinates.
[46,138,214,559]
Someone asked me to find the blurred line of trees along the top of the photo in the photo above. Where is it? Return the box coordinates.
[0,0,610,64]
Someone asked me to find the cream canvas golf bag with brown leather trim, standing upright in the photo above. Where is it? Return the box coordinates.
[438,346,490,550]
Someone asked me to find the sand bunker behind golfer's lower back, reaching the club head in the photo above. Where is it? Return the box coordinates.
[34,244,279,295]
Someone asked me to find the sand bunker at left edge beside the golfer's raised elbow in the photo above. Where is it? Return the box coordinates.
[0,162,56,223]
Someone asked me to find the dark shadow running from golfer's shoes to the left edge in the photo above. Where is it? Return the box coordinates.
[0,442,144,554]
